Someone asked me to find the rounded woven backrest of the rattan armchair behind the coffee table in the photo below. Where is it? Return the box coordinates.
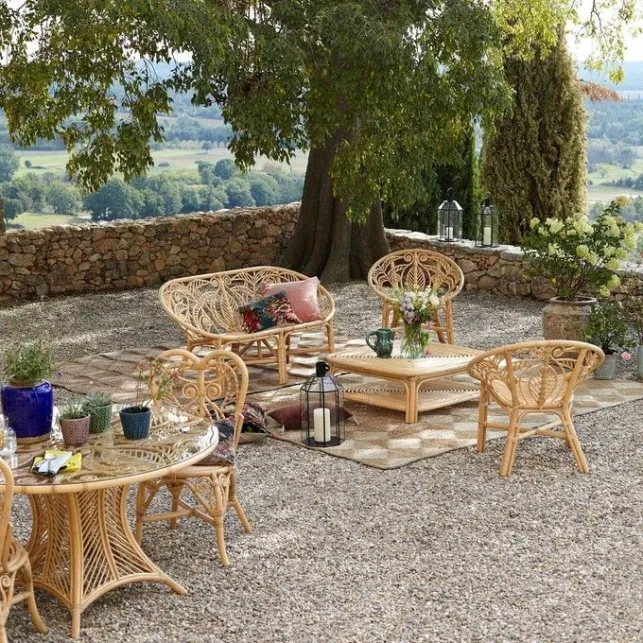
[368,249,464,301]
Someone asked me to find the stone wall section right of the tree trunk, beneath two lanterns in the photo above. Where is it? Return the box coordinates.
[387,230,643,300]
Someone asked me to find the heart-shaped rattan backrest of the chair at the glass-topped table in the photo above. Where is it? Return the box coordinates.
[150,348,248,442]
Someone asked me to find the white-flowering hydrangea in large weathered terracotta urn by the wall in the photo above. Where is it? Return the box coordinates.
[523,202,640,340]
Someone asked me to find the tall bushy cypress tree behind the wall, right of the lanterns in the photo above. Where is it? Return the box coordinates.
[482,35,587,244]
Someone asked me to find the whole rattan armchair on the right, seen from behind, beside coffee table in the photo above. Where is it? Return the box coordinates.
[468,340,605,476]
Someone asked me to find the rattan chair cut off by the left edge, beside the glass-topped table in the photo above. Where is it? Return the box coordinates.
[0,459,48,643]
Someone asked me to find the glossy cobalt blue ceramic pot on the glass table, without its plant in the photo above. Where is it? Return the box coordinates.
[0,382,54,441]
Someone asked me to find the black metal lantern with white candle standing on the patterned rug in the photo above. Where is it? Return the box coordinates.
[301,362,344,447]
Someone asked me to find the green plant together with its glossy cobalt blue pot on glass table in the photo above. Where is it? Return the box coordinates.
[0,342,54,442]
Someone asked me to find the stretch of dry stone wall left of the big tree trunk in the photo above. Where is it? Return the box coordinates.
[0,203,299,300]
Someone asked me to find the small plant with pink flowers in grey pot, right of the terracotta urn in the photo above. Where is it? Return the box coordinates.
[585,300,630,380]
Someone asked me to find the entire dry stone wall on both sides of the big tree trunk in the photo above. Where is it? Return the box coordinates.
[0,205,643,301]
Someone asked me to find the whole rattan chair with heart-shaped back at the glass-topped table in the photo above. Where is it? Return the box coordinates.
[135,349,252,566]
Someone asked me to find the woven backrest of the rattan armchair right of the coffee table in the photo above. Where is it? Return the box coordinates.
[468,340,604,408]
